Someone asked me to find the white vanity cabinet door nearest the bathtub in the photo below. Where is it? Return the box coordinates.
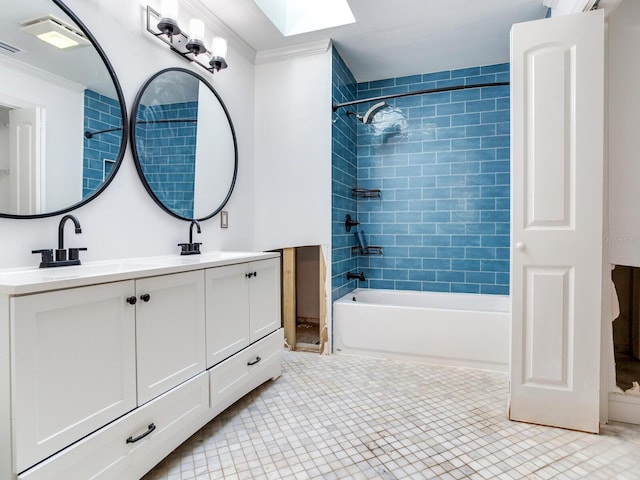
[249,258,282,342]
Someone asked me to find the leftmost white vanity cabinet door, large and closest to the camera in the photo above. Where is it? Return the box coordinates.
[11,281,136,472]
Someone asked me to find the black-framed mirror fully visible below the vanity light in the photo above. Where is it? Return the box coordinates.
[131,68,238,221]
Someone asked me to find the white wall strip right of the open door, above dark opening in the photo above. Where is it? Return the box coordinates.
[608,0,640,266]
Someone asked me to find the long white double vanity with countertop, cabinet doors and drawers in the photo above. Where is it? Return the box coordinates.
[0,252,284,480]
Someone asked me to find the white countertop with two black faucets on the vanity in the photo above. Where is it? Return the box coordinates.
[0,252,280,295]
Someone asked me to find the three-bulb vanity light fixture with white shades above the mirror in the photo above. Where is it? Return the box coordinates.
[147,0,227,73]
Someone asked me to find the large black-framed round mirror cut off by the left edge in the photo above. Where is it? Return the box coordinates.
[0,0,129,218]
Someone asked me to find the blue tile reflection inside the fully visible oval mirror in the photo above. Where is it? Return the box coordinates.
[136,101,198,218]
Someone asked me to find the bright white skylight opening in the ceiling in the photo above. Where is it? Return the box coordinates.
[253,0,356,37]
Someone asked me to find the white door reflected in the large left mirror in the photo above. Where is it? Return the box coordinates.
[9,107,46,215]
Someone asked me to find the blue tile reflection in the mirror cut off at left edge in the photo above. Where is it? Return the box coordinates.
[82,89,122,198]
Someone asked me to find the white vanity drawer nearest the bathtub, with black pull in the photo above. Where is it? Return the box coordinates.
[209,328,284,415]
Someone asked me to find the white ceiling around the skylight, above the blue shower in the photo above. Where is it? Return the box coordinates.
[199,0,547,82]
